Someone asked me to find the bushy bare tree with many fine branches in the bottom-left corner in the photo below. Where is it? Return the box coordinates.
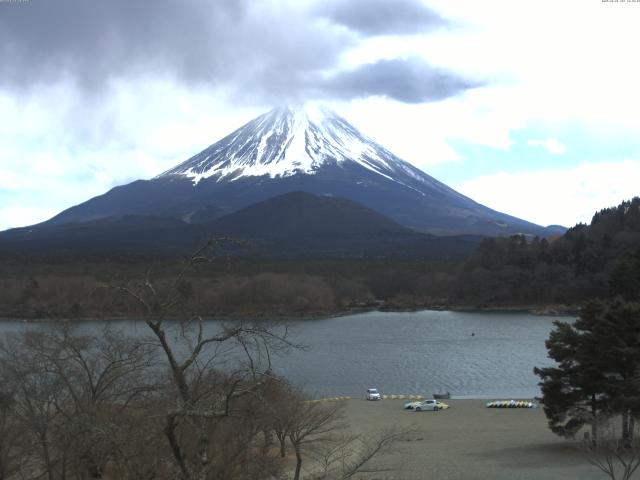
[0,324,160,480]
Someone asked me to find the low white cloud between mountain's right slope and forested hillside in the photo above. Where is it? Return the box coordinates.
[453,159,640,227]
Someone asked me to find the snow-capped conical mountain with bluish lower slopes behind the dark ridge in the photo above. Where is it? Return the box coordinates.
[47,104,555,235]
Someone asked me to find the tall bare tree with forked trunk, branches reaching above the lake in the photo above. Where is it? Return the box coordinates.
[117,239,289,480]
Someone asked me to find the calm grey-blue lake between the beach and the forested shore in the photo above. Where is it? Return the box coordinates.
[0,311,572,399]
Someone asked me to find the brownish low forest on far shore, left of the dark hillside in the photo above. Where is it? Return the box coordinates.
[0,260,456,319]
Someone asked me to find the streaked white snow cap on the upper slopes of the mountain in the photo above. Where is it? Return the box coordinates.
[158,103,457,202]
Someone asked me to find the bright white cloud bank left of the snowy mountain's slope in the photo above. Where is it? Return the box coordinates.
[0,80,262,231]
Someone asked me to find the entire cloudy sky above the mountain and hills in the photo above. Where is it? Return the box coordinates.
[0,0,640,230]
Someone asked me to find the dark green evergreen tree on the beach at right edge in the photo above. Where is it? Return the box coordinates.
[534,299,640,444]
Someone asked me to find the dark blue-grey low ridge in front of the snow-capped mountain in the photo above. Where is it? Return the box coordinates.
[0,192,481,260]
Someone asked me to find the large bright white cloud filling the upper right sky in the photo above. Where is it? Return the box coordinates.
[343,0,640,159]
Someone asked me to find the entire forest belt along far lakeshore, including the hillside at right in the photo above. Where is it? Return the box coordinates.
[0,198,640,318]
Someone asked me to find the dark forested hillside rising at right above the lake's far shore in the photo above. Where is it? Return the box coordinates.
[452,197,640,305]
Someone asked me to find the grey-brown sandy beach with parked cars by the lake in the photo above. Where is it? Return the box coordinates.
[338,399,606,480]
